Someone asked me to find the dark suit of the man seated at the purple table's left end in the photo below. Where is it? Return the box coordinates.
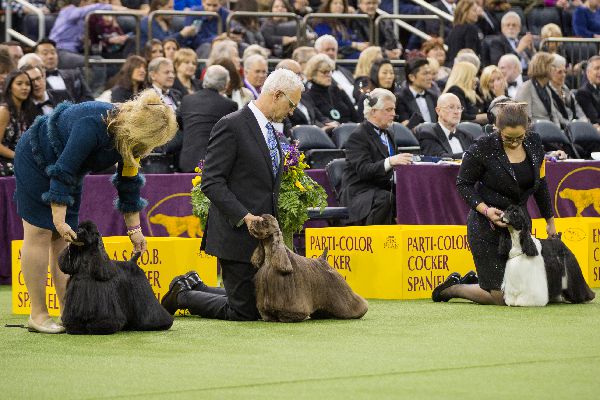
[340,121,394,222]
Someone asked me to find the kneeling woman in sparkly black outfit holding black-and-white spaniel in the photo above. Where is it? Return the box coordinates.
[432,102,556,305]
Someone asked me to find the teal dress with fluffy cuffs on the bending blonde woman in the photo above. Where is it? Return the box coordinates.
[14,101,147,231]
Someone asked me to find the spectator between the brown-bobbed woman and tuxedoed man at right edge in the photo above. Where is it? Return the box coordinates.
[549,54,588,128]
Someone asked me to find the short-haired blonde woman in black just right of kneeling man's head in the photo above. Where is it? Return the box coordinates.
[304,54,358,123]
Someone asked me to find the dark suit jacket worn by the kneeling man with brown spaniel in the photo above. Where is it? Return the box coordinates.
[202,106,283,263]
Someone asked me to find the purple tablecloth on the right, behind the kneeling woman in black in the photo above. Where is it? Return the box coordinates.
[395,161,600,225]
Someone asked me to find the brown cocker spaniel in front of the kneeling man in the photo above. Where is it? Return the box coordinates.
[249,214,368,322]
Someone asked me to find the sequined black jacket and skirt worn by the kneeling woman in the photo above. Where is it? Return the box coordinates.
[456,132,553,290]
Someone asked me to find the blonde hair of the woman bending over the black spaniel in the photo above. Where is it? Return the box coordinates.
[106,89,178,166]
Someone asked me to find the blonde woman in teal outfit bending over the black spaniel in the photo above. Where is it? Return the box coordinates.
[15,89,177,333]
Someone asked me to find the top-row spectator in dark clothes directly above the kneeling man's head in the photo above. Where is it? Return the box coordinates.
[261,0,298,58]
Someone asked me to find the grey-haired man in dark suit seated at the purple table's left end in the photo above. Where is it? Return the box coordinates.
[340,88,412,225]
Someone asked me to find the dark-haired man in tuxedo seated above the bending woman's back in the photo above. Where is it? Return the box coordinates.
[35,39,94,103]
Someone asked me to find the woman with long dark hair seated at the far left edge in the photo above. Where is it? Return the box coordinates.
[0,70,37,176]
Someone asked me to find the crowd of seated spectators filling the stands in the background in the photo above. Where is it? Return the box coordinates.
[0,0,600,175]
